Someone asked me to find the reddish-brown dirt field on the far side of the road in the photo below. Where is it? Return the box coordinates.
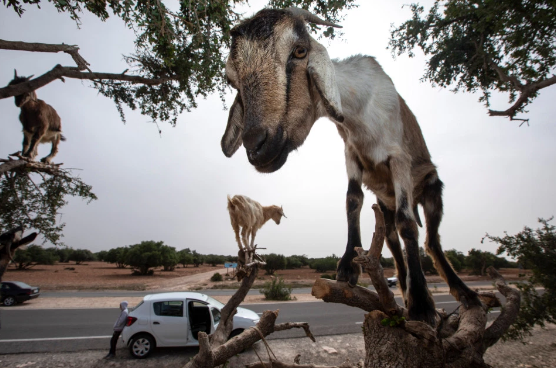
[4,262,523,290]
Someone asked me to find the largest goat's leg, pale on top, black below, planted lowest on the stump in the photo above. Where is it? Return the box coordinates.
[390,156,436,326]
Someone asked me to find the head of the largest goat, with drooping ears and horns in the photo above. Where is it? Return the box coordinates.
[222,8,343,172]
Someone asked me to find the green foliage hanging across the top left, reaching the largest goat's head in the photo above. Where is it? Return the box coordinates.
[0,0,354,124]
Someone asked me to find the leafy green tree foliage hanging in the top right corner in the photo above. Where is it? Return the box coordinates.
[389,0,556,119]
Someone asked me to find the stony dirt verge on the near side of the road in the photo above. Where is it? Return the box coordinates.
[0,325,556,368]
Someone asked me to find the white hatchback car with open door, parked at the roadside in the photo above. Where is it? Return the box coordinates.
[121,292,260,358]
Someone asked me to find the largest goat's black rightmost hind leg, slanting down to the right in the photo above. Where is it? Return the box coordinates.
[421,173,481,307]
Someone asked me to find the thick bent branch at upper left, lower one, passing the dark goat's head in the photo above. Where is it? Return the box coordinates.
[0,64,171,99]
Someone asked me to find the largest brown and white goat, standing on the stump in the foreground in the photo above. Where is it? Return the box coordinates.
[222,8,479,325]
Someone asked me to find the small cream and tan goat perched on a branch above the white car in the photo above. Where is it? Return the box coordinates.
[228,195,286,251]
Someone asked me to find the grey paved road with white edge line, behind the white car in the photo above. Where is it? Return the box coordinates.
[0,295,499,354]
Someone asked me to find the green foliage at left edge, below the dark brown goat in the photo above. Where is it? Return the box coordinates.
[0,169,97,245]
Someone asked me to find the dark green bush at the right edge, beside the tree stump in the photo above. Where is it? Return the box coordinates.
[485,218,556,339]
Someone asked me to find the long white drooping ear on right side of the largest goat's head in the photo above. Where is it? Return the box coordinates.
[307,40,344,123]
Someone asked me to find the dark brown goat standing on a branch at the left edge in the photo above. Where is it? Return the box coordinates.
[8,70,66,163]
